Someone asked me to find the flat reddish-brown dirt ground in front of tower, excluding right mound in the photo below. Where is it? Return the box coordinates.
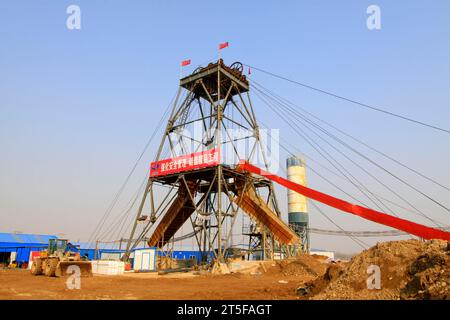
[0,257,326,300]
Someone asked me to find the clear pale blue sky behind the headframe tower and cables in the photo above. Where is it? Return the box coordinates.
[0,0,450,251]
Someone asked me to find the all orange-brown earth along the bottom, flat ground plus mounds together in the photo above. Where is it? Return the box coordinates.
[0,240,450,300]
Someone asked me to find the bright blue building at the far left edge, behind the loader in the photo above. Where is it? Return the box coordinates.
[0,233,57,265]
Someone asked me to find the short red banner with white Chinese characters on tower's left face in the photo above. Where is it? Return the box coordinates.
[150,148,220,177]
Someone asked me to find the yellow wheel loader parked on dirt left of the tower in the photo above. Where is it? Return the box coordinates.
[31,239,92,277]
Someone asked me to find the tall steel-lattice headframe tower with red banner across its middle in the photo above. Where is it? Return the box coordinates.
[123,59,295,262]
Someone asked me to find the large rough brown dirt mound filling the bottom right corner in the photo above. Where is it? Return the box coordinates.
[306,240,450,299]
